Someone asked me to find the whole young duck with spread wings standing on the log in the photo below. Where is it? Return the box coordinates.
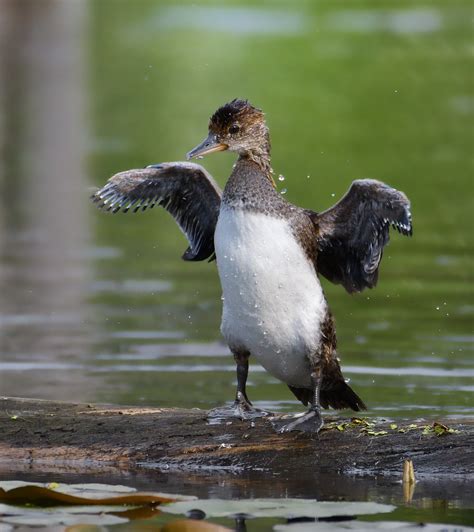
[94,100,412,431]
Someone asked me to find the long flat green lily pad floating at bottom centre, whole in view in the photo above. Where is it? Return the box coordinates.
[161,499,395,518]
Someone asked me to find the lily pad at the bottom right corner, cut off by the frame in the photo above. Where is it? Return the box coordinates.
[273,520,474,532]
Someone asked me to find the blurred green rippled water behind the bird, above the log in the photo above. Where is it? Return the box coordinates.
[0,0,474,522]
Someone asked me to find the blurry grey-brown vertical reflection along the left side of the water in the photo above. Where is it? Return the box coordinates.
[0,1,94,397]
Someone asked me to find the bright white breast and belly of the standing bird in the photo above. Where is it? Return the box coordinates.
[215,207,327,387]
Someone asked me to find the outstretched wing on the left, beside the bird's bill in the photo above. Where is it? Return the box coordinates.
[92,162,222,261]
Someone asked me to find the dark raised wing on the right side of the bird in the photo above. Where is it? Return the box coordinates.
[311,179,412,293]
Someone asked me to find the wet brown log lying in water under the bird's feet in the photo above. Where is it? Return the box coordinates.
[0,398,474,481]
